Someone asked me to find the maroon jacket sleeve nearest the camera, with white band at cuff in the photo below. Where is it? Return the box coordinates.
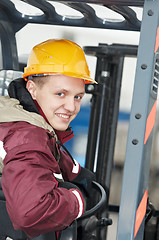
[2,125,84,238]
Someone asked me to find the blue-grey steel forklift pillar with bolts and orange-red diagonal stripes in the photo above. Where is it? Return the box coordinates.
[117,1,159,240]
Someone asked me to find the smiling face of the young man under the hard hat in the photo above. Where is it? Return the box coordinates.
[26,75,85,131]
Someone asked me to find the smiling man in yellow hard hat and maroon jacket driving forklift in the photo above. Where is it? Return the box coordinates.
[0,39,95,238]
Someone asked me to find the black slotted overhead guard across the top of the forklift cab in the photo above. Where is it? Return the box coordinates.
[0,0,144,32]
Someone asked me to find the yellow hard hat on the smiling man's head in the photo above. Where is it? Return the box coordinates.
[23,39,96,84]
